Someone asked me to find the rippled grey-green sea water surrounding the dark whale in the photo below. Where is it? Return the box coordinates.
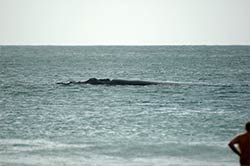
[0,46,250,166]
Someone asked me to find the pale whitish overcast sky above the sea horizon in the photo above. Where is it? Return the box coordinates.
[0,0,250,45]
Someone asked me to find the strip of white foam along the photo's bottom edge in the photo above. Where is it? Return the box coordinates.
[0,155,237,166]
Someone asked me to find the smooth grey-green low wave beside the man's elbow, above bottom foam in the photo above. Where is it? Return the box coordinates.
[85,142,227,158]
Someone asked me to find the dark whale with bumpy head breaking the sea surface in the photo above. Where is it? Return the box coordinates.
[57,78,160,86]
